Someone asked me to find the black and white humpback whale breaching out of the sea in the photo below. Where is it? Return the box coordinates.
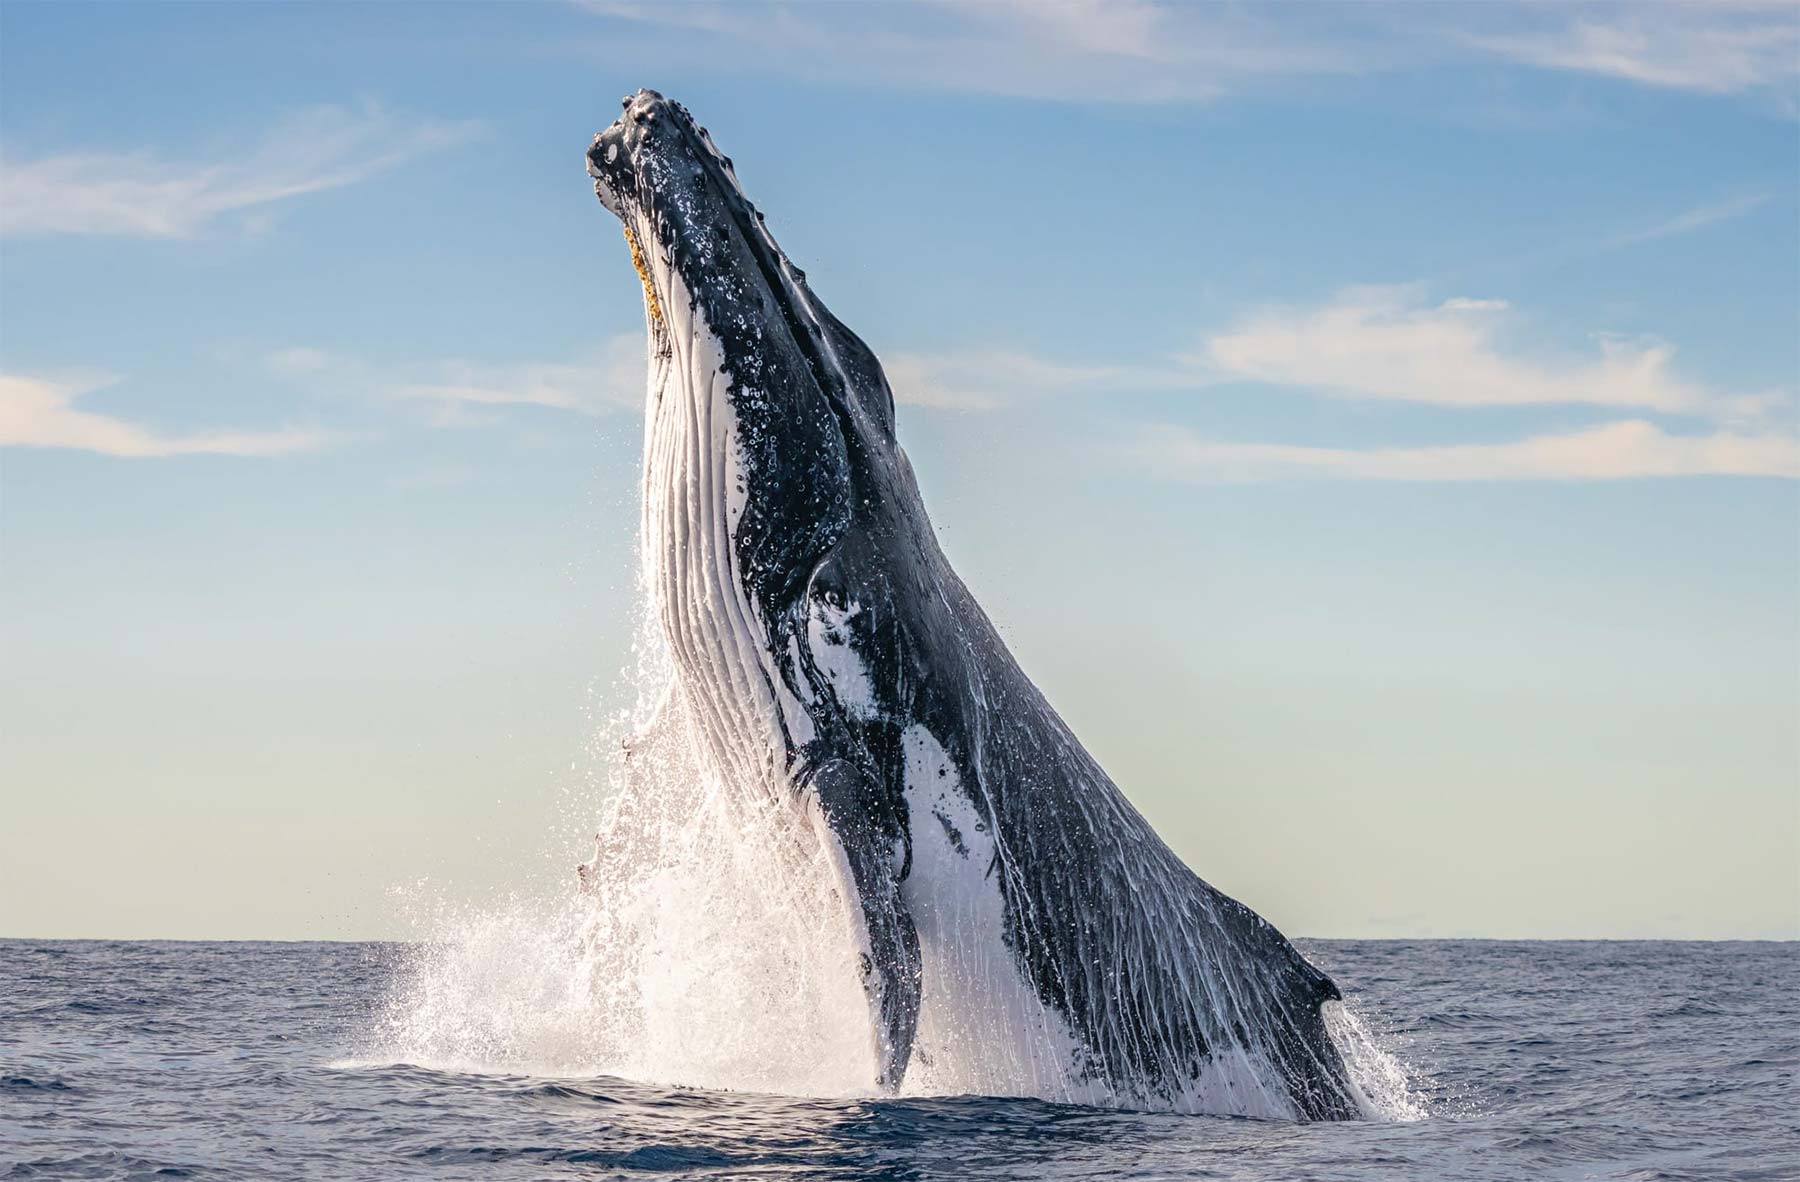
[587,90,1361,1119]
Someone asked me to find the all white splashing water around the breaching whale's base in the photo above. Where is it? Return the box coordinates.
[356,586,1424,1121]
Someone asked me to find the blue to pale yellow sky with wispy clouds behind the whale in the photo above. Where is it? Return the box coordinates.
[0,0,1800,939]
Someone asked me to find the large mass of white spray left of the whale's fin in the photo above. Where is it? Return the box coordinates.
[371,694,873,1096]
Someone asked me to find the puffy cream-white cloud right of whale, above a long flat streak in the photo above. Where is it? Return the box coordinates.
[1193,286,1773,417]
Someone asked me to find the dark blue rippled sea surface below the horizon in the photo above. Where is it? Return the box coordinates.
[0,941,1800,1180]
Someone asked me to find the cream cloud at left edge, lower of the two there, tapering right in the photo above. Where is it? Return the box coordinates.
[0,374,328,457]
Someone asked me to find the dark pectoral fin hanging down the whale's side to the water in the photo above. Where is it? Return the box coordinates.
[812,759,922,1092]
